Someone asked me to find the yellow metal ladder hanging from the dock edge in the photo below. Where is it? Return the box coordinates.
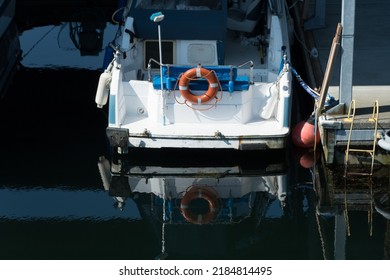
[344,100,379,177]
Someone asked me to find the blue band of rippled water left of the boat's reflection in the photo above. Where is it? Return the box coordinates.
[0,186,140,222]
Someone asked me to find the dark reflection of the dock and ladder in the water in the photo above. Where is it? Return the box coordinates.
[315,154,390,259]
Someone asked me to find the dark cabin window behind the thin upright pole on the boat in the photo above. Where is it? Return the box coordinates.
[144,40,175,69]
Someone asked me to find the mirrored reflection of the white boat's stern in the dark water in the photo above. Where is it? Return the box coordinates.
[98,152,288,259]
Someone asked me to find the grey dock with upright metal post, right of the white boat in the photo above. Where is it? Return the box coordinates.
[296,0,390,164]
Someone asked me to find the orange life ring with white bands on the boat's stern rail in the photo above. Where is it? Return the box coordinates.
[179,67,219,104]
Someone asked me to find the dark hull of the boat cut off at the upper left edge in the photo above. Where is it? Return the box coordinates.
[0,0,21,95]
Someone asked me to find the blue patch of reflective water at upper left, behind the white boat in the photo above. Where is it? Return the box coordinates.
[20,21,117,70]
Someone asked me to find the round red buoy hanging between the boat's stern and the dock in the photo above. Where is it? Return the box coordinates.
[292,117,321,148]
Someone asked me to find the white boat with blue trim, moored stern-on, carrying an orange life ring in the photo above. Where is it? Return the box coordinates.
[96,0,292,153]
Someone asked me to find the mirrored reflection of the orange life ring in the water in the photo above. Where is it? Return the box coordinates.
[180,187,219,225]
